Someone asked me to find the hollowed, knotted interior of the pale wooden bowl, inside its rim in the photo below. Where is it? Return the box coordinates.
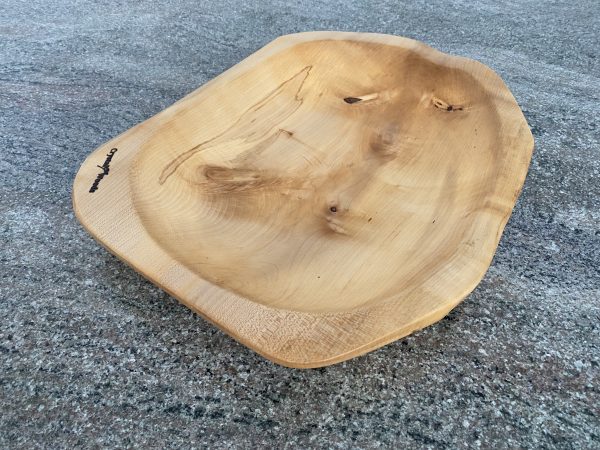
[130,40,502,313]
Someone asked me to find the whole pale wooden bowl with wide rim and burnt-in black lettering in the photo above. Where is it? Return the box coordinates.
[73,32,533,367]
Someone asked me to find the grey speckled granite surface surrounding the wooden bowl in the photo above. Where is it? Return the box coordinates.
[0,0,600,449]
